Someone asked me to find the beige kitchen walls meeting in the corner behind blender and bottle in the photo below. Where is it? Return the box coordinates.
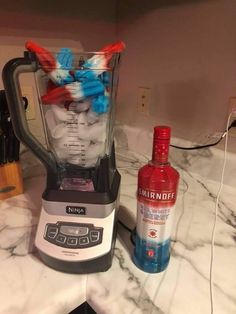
[0,0,236,151]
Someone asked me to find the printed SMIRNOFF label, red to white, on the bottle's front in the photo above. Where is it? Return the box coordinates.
[137,188,176,246]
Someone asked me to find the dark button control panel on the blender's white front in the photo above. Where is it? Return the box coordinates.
[44,221,103,249]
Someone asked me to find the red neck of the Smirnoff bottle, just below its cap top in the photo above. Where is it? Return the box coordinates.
[152,136,170,164]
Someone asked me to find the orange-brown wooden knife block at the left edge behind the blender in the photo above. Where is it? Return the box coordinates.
[0,161,23,200]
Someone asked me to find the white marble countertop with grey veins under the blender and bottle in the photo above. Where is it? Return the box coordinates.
[0,126,236,314]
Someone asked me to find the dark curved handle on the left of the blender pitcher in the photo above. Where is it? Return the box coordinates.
[2,52,57,174]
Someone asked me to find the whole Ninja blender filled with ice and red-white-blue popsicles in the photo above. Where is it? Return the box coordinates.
[3,41,124,273]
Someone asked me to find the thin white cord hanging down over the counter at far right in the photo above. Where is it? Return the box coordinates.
[210,112,230,314]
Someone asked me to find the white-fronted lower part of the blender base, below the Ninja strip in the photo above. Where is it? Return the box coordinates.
[35,202,118,274]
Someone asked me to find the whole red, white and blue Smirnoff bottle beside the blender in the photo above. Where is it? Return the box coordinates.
[133,126,179,273]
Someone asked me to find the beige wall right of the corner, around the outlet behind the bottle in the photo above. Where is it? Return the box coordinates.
[117,0,236,152]
